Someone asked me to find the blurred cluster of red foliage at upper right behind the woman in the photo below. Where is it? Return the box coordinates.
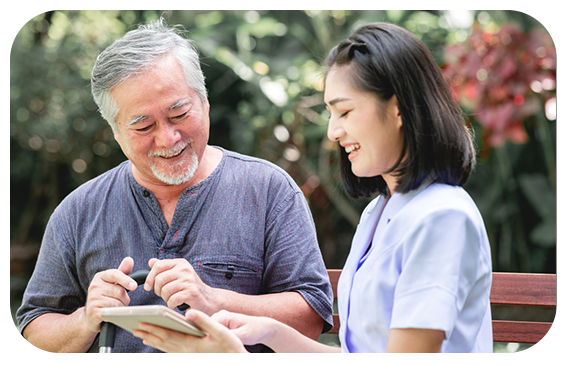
[442,24,556,147]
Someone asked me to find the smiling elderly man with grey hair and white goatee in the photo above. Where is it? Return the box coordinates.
[17,20,332,352]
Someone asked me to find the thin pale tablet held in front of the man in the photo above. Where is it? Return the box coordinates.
[102,305,205,337]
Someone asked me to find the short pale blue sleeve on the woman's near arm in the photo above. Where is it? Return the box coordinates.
[390,209,481,338]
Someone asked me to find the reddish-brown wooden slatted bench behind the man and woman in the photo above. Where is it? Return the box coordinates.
[327,270,557,345]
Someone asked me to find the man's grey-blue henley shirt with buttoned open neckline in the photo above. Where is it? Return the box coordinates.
[17,149,333,352]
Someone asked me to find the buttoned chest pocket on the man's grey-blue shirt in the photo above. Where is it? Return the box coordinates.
[191,257,263,295]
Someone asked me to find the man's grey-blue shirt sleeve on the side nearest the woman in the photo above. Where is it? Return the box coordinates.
[264,189,333,332]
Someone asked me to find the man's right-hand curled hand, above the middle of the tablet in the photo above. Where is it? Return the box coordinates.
[144,259,221,315]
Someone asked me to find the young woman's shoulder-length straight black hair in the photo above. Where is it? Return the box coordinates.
[327,23,476,198]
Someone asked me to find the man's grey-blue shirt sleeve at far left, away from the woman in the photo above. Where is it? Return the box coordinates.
[16,202,86,332]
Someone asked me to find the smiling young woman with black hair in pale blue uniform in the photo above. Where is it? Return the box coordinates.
[135,23,492,352]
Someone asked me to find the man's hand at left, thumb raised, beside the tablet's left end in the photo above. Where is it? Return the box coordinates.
[85,257,138,332]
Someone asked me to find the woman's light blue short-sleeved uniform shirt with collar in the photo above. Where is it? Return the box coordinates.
[338,184,492,352]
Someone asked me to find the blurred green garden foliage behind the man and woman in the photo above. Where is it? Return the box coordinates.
[10,10,557,352]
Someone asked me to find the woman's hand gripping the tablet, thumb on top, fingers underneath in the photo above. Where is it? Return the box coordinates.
[134,309,247,353]
